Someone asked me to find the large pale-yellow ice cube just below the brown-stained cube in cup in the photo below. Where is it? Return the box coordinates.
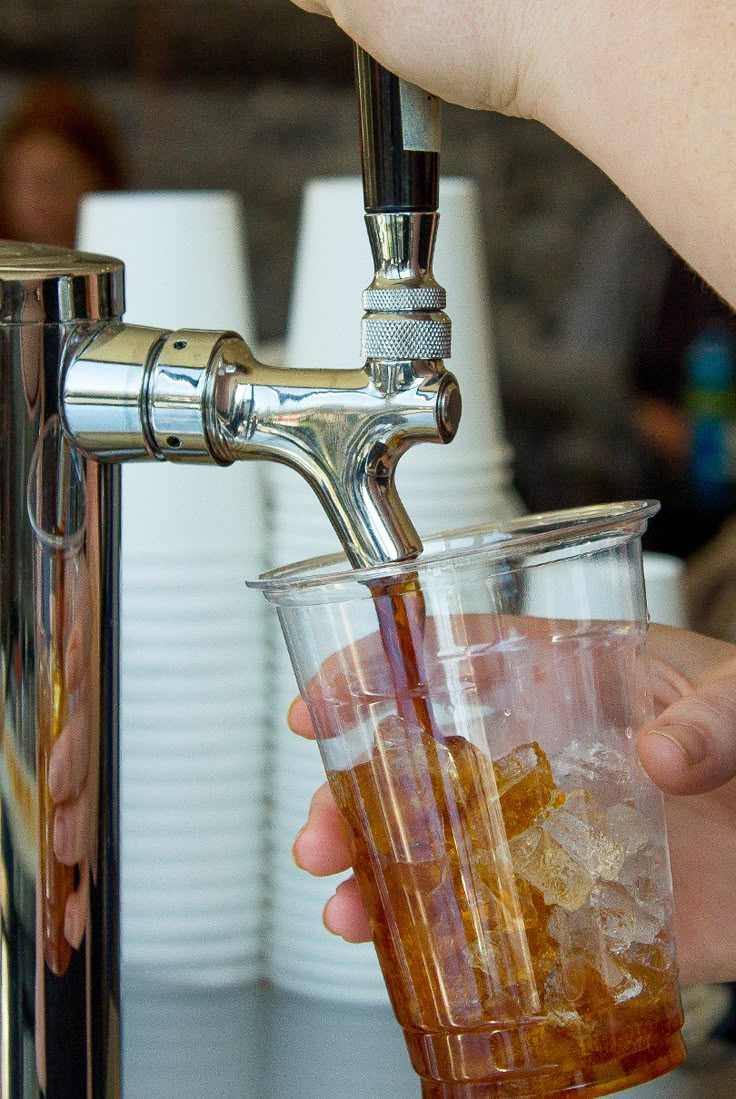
[509,824,593,911]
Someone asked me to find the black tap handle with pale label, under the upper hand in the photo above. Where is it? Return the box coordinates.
[355,46,441,213]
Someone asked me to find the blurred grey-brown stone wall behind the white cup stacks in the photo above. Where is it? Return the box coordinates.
[0,0,703,551]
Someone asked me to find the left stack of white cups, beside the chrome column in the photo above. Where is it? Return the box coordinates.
[79,192,272,987]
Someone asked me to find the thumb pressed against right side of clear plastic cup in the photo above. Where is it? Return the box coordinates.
[638,664,736,793]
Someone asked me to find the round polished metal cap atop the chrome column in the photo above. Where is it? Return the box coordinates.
[0,241,125,324]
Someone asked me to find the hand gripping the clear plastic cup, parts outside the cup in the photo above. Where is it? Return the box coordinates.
[289,626,736,984]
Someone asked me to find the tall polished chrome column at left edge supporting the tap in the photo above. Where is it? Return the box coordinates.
[0,245,122,1099]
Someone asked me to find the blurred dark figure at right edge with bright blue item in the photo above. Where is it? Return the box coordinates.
[631,253,736,558]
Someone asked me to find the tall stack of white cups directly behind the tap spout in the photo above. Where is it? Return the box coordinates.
[268,177,521,1003]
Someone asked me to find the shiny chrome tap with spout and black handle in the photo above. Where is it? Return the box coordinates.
[60,49,460,566]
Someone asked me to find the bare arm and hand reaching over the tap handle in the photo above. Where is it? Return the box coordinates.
[297,0,736,304]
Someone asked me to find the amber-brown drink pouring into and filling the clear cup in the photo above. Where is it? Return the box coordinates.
[328,576,684,1099]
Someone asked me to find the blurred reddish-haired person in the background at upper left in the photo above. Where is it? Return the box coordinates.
[0,79,123,248]
